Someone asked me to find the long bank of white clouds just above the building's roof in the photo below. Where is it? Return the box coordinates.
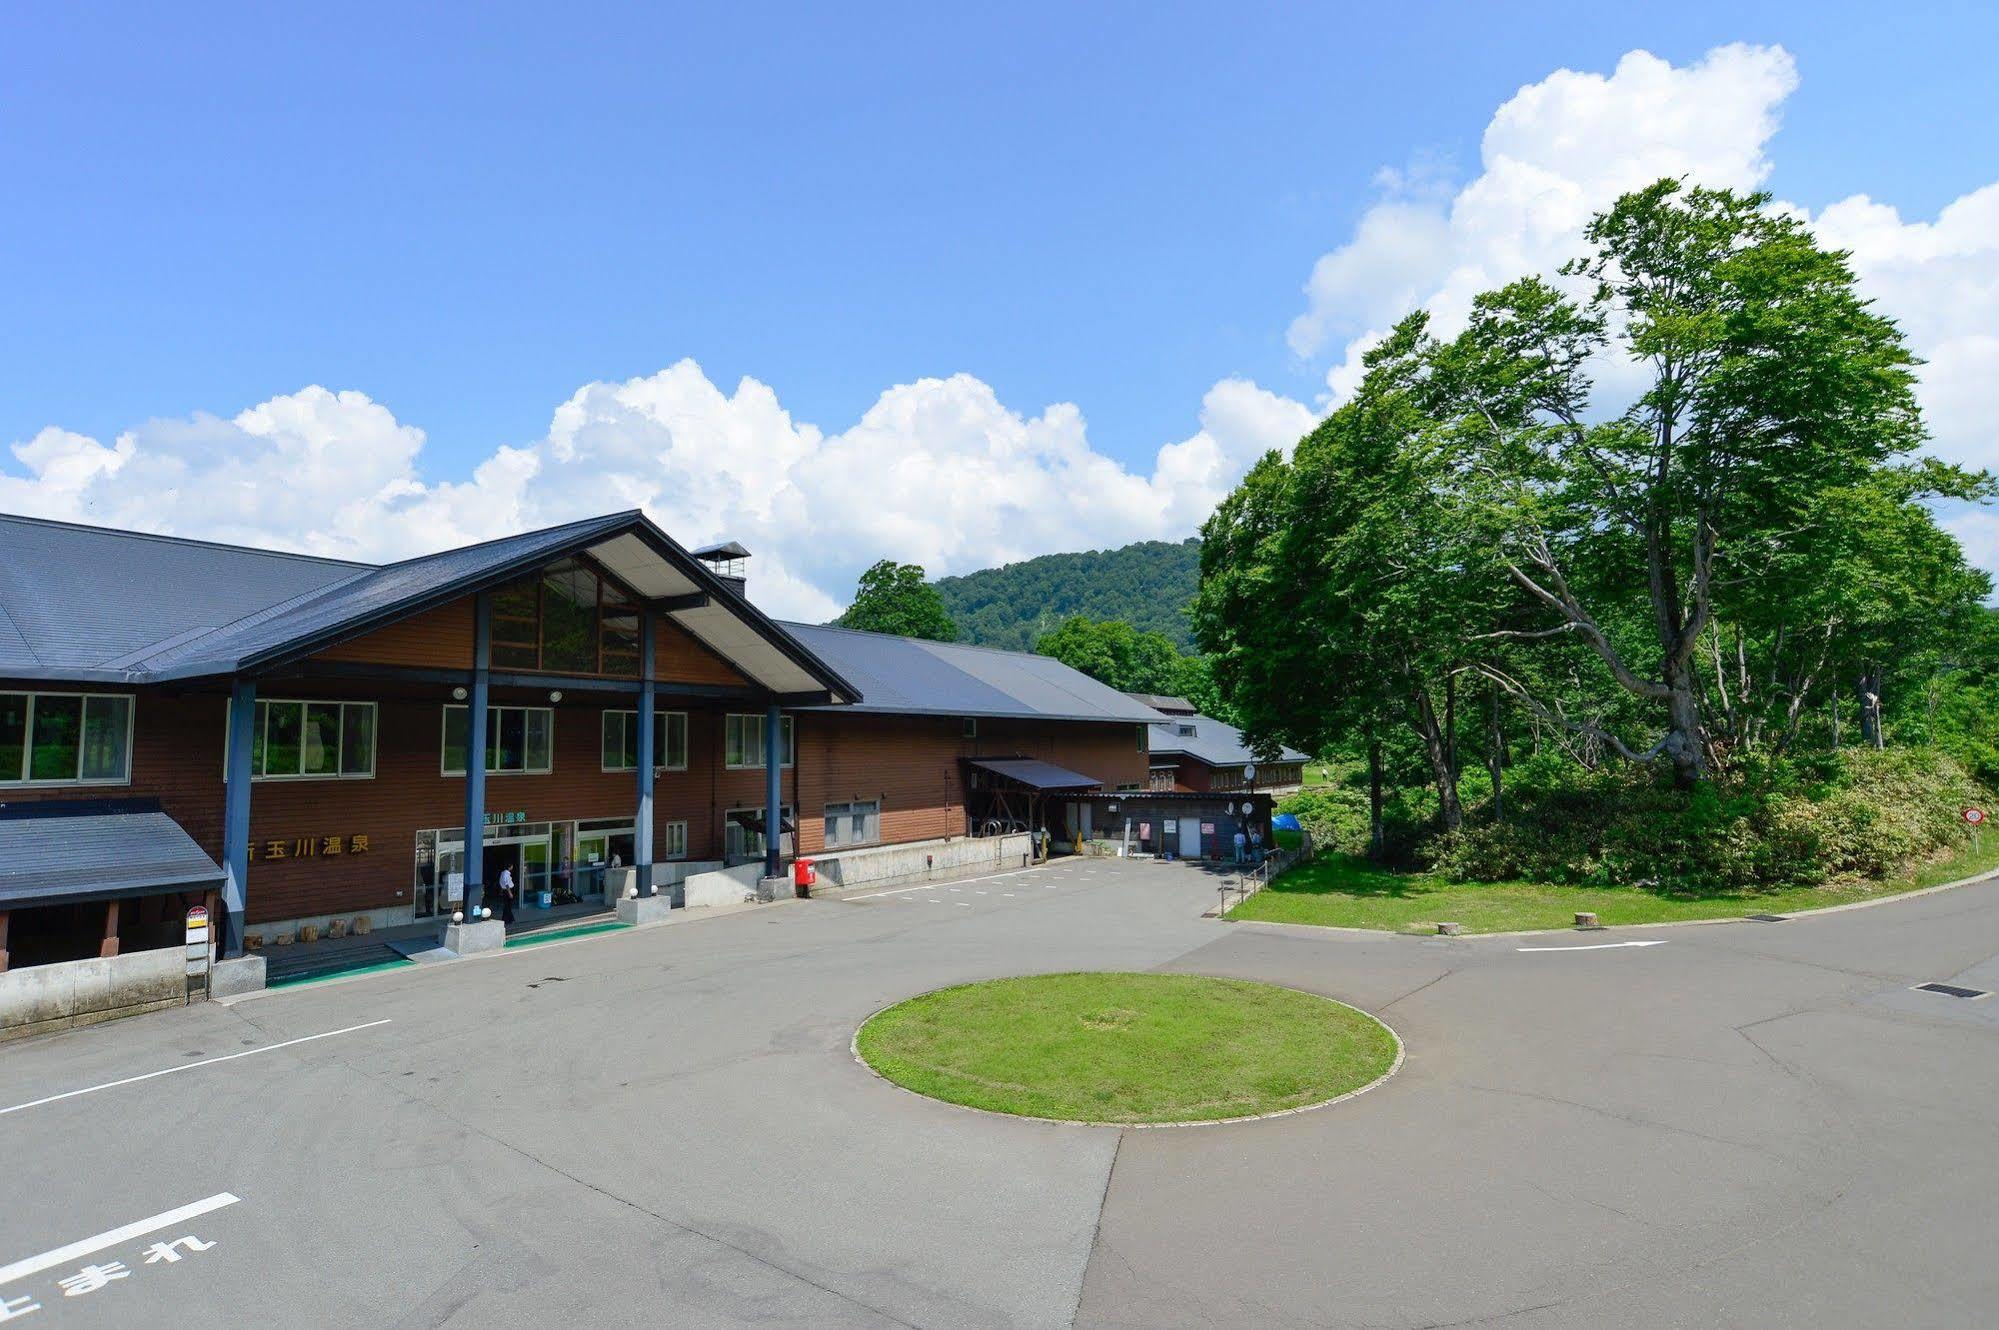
[0,360,1313,618]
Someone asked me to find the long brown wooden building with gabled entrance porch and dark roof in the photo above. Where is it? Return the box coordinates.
[0,512,1159,992]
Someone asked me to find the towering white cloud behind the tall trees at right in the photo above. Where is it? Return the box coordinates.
[1289,44,1999,504]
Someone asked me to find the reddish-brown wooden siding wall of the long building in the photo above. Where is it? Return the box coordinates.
[0,680,1147,924]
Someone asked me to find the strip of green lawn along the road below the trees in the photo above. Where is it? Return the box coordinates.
[1229,834,1999,932]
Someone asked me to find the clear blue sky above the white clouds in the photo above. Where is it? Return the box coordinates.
[0,2,1999,616]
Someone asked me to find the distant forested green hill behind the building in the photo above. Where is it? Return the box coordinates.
[936,540,1201,652]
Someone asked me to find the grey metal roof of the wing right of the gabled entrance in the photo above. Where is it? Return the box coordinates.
[784,624,1159,724]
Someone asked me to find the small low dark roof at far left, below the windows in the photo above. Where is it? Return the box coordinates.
[0,800,222,910]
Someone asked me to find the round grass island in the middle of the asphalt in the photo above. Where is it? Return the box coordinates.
[854,974,1401,1126]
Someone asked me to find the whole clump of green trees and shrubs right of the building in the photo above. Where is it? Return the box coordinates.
[1193,180,1993,884]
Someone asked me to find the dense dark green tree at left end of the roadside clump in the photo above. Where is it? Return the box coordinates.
[1193,316,1505,828]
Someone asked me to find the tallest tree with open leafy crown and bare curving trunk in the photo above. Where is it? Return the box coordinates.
[1429,180,1975,784]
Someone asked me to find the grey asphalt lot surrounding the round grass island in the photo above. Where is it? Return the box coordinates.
[0,862,1999,1326]
